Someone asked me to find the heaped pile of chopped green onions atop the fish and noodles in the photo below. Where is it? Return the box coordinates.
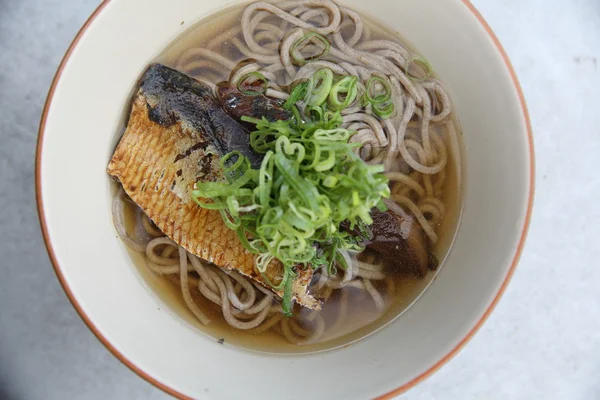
[192,108,390,315]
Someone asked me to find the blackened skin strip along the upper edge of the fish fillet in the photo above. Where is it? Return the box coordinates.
[139,64,262,167]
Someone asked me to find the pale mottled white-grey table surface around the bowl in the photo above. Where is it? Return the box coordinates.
[0,0,600,400]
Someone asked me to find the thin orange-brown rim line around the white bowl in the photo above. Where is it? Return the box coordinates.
[35,0,535,400]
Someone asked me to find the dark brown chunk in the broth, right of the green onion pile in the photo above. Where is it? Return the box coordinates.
[366,209,437,278]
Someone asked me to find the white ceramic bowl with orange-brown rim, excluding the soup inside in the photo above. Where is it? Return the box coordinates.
[36,0,533,400]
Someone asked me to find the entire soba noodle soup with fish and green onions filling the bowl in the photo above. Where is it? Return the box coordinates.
[108,1,461,353]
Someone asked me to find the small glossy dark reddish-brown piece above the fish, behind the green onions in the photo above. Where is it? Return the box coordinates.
[217,82,292,129]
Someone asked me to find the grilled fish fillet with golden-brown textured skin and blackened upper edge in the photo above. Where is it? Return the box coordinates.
[107,64,320,309]
